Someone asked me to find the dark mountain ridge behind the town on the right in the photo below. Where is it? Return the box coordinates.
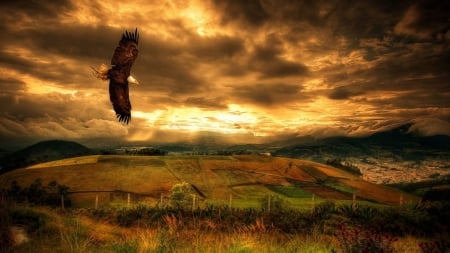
[273,124,450,162]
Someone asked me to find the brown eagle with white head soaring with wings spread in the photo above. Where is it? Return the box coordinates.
[93,28,139,124]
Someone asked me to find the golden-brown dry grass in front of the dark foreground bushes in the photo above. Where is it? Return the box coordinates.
[5,207,444,253]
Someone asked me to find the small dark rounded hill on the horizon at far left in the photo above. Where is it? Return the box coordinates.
[0,140,94,173]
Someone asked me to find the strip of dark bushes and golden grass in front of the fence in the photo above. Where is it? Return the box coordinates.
[0,198,450,252]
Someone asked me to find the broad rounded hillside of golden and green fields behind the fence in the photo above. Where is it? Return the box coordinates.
[0,155,418,208]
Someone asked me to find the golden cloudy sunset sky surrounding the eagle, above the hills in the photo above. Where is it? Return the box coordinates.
[0,0,450,148]
